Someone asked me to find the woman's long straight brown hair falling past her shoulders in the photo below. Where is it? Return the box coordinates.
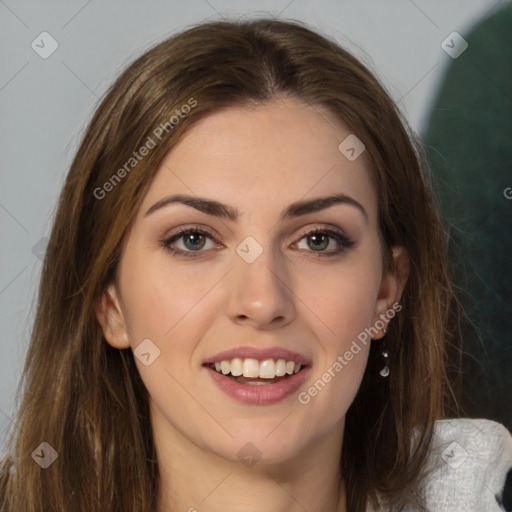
[0,19,455,512]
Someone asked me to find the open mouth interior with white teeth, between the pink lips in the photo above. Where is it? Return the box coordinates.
[205,357,307,386]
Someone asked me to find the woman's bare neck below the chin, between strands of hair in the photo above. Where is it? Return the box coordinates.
[153,412,346,512]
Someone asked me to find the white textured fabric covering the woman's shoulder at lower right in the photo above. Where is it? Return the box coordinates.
[423,419,512,512]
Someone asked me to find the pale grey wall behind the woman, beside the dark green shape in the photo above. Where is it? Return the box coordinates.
[0,0,504,447]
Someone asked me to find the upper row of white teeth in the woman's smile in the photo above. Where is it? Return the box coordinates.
[209,357,301,379]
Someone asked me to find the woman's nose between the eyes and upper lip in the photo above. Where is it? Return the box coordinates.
[225,243,296,329]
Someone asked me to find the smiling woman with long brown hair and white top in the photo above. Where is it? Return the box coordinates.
[0,20,512,512]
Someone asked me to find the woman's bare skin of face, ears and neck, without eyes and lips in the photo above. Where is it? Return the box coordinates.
[97,97,408,512]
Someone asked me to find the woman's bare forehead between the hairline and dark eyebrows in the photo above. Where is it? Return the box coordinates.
[143,97,376,222]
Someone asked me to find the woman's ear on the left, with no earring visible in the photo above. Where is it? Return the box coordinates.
[96,283,130,349]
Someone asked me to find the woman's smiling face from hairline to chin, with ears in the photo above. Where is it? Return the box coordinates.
[98,98,404,463]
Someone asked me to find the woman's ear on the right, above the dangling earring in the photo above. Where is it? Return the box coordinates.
[372,246,409,340]
